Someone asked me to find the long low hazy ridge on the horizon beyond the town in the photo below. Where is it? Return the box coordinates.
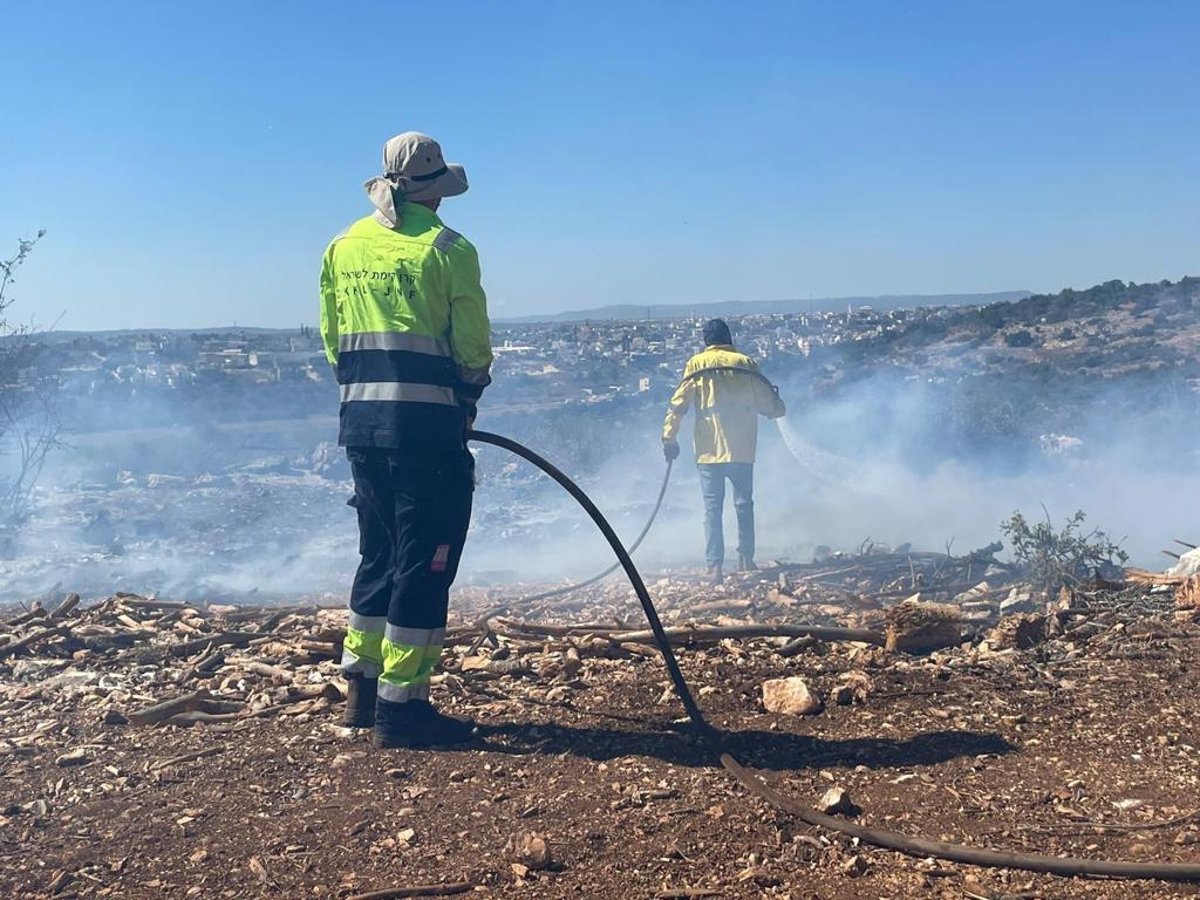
[497,290,1031,323]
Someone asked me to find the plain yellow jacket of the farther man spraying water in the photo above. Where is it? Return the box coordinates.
[662,344,787,463]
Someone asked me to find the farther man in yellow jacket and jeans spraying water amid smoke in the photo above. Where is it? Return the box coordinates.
[662,319,787,582]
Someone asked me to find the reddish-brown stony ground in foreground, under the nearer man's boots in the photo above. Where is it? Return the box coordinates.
[0,566,1200,900]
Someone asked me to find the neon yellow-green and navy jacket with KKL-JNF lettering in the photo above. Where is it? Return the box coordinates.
[320,203,492,448]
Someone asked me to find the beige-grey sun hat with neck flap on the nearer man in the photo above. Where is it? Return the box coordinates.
[362,131,468,227]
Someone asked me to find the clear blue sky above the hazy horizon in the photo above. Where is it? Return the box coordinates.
[0,0,1200,329]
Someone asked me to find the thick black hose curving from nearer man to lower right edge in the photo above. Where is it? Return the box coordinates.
[468,431,1200,881]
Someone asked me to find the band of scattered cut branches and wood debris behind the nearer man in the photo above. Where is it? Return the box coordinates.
[0,546,1180,755]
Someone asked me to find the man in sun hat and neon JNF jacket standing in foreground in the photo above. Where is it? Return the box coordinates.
[320,132,492,748]
